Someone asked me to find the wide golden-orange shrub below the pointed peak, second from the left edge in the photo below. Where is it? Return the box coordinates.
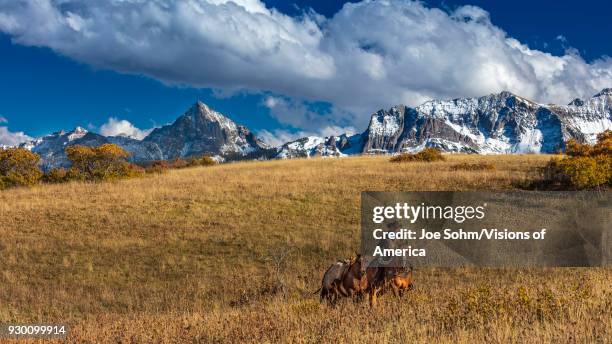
[66,144,144,180]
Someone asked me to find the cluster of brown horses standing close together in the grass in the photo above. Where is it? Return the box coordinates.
[315,254,413,306]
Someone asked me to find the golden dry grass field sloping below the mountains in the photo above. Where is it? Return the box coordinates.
[0,155,612,343]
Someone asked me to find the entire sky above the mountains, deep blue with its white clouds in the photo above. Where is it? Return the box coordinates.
[0,0,612,144]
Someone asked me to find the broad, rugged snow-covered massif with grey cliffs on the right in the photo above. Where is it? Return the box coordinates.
[281,88,612,158]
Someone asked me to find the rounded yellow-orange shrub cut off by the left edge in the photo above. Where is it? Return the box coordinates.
[0,148,43,189]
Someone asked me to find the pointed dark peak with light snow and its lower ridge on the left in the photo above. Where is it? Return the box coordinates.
[20,102,267,170]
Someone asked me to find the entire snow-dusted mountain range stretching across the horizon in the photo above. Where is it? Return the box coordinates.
[9,88,612,169]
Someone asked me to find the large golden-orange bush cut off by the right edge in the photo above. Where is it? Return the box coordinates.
[543,130,612,189]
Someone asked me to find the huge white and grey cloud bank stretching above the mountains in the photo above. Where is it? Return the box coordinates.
[0,0,612,132]
